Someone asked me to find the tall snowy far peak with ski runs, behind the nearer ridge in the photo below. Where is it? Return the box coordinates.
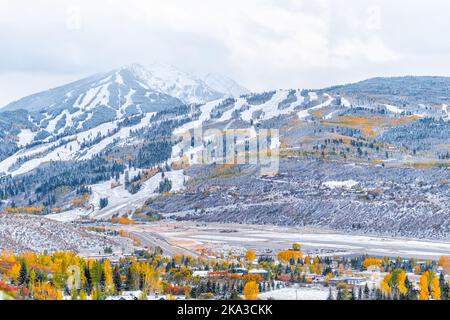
[0,64,250,149]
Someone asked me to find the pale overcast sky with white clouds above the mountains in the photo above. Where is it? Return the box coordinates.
[0,0,450,106]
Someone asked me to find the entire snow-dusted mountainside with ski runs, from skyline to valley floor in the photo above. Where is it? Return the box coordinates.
[0,69,450,239]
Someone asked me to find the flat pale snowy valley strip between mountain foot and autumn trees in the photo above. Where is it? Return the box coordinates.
[117,221,450,260]
